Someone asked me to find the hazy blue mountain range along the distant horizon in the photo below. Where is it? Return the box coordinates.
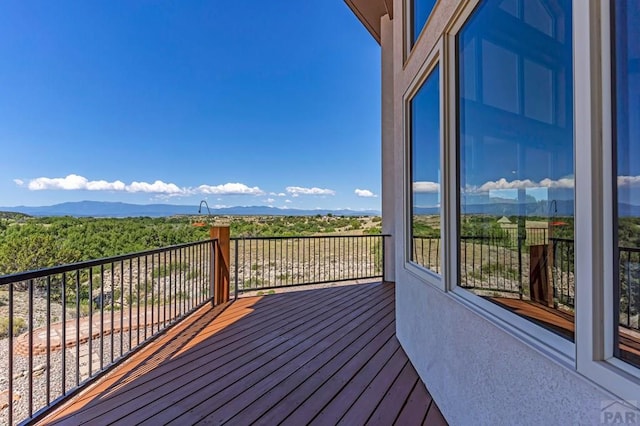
[0,201,380,217]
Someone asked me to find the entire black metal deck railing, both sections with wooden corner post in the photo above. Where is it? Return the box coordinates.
[0,232,385,424]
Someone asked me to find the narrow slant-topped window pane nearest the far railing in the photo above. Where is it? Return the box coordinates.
[409,66,441,273]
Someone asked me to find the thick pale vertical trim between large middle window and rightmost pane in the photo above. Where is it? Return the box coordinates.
[573,0,640,403]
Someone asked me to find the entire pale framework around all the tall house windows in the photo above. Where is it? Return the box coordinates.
[402,0,640,404]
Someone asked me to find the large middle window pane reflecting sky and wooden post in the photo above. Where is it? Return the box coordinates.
[456,0,575,340]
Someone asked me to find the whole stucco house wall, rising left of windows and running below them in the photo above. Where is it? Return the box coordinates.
[382,0,616,425]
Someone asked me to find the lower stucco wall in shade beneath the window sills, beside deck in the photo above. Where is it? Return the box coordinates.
[396,274,614,425]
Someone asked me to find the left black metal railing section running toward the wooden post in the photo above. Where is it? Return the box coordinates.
[0,240,217,424]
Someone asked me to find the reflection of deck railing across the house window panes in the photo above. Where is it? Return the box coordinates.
[413,228,640,331]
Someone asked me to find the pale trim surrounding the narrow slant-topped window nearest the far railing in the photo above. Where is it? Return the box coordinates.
[402,39,447,291]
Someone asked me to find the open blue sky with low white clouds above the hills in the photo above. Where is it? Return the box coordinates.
[0,0,380,209]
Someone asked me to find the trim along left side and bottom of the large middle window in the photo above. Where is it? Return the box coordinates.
[443,0,576,369]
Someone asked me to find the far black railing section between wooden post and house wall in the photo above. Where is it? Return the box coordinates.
[230,235,385,293]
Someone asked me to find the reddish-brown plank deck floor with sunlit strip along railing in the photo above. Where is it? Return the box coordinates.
[41,283,446,425]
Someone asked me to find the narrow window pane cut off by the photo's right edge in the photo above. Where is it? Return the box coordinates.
[612,1,640,367]
